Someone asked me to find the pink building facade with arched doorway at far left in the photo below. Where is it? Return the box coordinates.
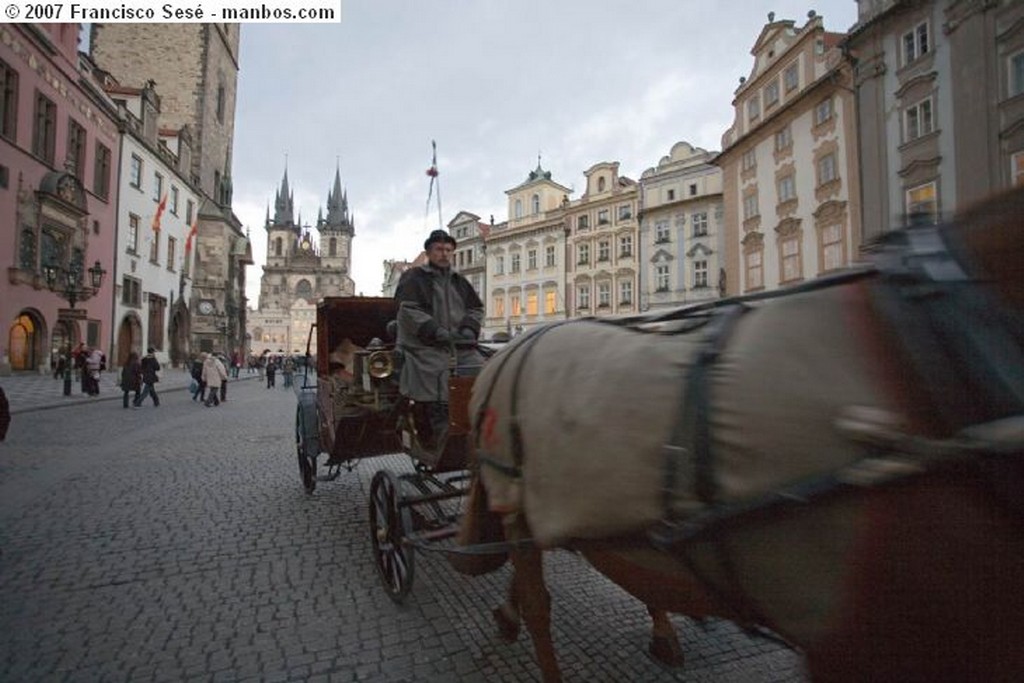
[0,24,120,374]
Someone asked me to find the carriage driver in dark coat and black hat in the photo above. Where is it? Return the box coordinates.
[395,230,483,447]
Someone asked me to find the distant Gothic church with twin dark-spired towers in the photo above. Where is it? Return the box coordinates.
[248,169,355,354]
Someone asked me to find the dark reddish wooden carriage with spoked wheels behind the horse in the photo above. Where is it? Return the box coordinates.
[295,297,493,602]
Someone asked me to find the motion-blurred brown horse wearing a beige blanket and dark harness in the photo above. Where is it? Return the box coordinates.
[457,189,1024,683]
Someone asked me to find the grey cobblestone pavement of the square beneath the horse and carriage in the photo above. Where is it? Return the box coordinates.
[0,376,805,683]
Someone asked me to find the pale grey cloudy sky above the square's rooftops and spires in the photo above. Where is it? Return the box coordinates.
[232,0,857,306]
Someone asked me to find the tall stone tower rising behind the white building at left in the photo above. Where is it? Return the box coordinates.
[90,24,253,361]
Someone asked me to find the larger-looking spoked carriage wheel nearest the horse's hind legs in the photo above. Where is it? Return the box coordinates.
[370,470,415,604]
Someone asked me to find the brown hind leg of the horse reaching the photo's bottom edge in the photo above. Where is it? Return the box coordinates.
[505,515,562,683]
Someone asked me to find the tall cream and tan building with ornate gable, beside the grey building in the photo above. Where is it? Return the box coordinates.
[715,11,862,294]
